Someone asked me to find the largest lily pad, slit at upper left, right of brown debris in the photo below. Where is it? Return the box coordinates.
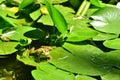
[49,43,109,76]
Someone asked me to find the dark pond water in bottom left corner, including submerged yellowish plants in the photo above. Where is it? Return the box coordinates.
[0,54,35,80]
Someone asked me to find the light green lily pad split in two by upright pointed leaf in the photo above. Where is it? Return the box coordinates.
[37,5,75,26]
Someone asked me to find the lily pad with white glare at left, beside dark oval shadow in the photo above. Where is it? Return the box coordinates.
[2,26,35,41]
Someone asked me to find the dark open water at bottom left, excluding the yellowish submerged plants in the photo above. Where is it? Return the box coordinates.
[0,54,35,80]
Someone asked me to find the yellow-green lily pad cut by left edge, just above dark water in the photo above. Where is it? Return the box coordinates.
[0,42,18,55]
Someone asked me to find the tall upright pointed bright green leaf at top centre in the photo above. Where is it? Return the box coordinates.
[44,0,67,33]
